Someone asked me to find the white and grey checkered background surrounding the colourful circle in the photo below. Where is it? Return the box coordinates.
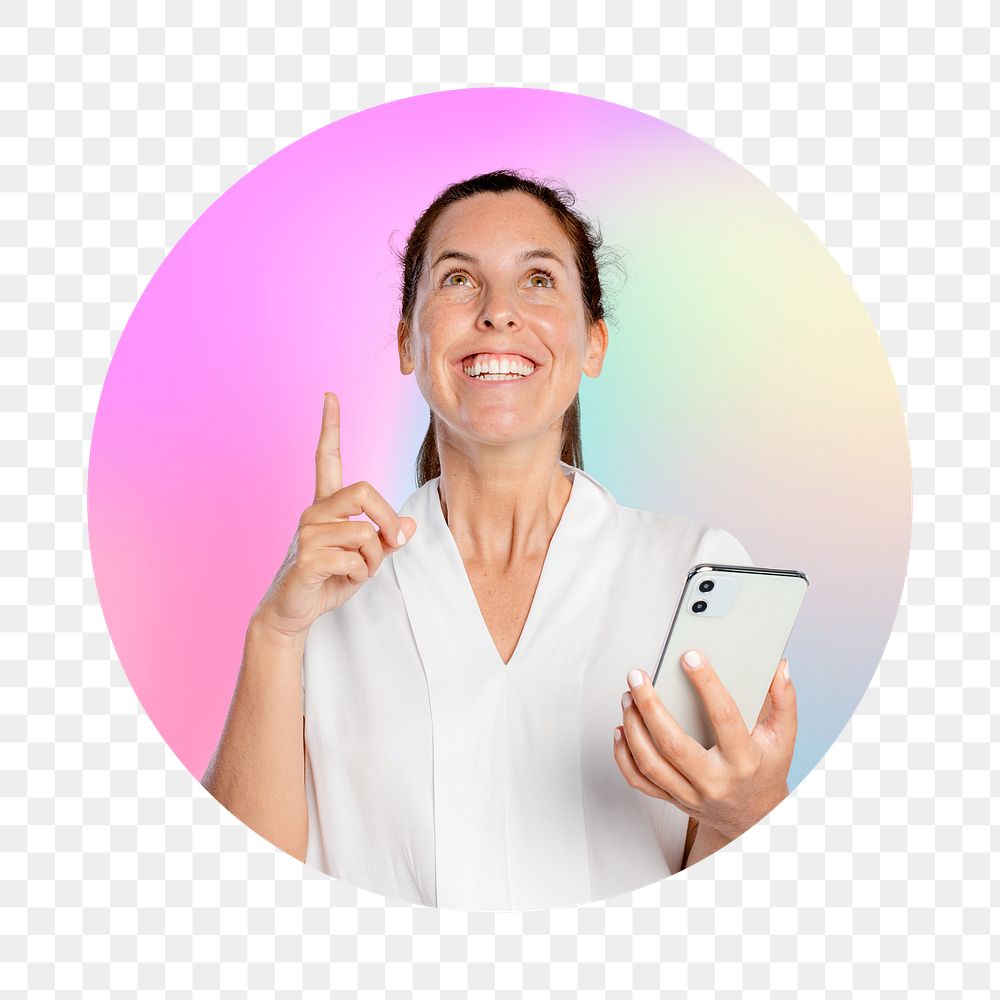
[0,0,1000,998]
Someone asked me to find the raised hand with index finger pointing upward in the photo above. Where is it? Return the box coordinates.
[254,392,417,638]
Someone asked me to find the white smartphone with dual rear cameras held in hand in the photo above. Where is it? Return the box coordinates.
[652,563,809,749]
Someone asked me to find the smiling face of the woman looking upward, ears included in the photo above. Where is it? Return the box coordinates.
[398,192,608,454]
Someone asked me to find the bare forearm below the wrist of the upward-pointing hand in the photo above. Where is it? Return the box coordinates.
[201,618,308,861]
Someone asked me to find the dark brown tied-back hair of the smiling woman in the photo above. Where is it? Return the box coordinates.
[397,170,620,486]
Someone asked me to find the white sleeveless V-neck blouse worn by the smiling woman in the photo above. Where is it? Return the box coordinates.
[302,463,751,911]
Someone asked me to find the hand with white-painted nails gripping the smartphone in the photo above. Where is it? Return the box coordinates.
[614,650,798,841]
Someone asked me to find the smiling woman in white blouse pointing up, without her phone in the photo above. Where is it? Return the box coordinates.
[204,170,796,910]
